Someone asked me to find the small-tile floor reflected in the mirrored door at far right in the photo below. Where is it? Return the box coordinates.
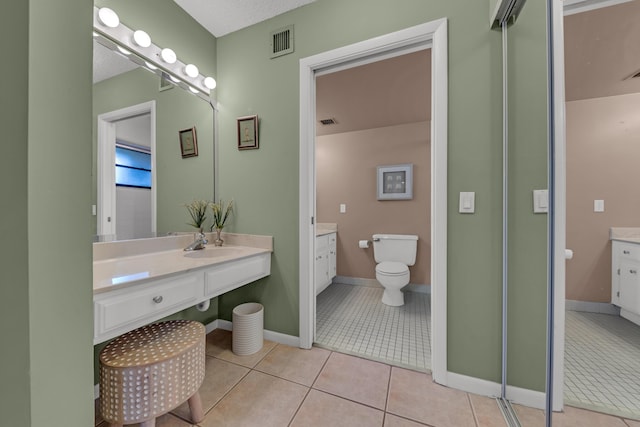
[564,311,640,419]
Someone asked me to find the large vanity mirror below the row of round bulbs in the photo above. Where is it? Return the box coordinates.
[93,40,214,241]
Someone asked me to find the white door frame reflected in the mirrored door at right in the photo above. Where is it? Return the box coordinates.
[553,0,631,411]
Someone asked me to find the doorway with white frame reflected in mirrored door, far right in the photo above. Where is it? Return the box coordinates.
[553,0,640,419]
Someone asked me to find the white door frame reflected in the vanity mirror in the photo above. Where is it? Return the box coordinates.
[97,100,157,235]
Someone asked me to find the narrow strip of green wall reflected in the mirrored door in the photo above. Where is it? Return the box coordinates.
[507,1,548,391]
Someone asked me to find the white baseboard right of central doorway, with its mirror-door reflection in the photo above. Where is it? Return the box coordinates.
[445,372,545,409]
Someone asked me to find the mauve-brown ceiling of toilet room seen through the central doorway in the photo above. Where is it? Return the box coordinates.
[316,49,431,135]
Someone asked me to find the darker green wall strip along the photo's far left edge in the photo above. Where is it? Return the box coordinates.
[0,1,31,426]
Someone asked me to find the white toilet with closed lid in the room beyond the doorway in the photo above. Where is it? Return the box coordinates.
[373,234,418,306]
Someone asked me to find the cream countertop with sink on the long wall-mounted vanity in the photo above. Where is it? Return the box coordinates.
[93,234,273,294]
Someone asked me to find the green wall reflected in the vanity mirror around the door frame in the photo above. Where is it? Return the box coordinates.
[93,68,213,234]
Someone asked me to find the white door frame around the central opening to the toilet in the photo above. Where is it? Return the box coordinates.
[299,18,448,384]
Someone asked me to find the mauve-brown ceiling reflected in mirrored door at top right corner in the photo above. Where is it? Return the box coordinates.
[564,0,640,101]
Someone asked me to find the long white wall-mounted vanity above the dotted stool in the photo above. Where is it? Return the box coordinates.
[93,233,273,344]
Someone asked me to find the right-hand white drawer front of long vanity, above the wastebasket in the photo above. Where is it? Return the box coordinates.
[205,253,271,298]
